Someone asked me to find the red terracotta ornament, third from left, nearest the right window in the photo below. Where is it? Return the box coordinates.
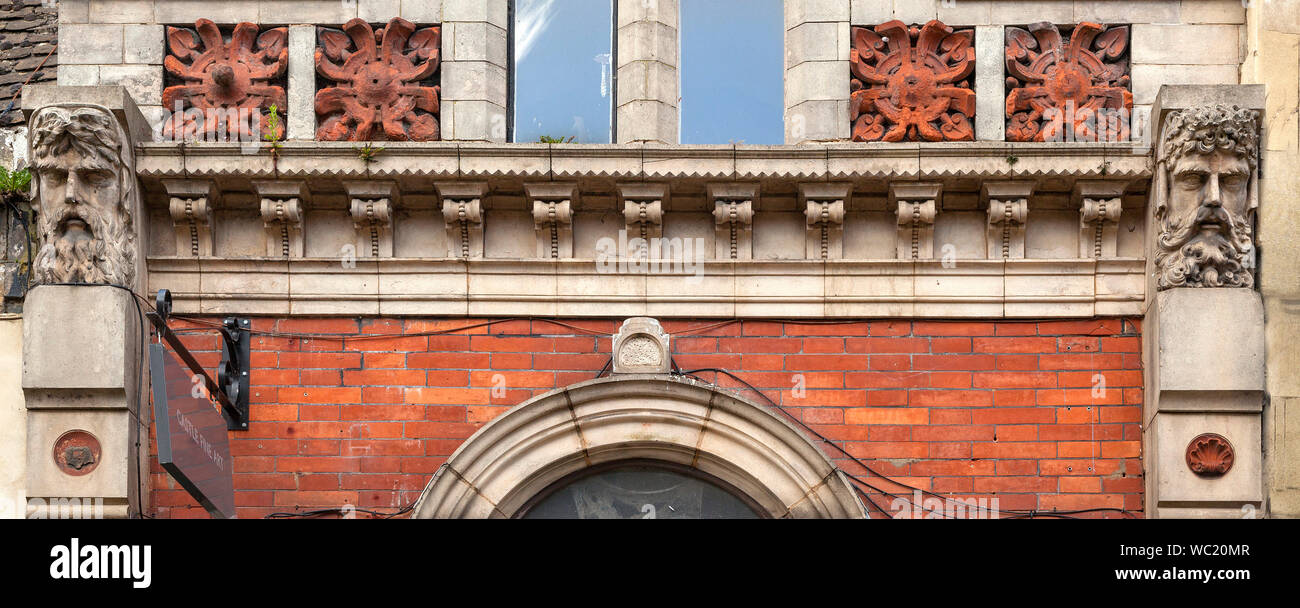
[849,21,975,142]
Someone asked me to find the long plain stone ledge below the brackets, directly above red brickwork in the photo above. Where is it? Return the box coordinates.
[150,257,1144,318]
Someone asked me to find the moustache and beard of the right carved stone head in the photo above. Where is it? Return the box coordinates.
[1156,205,1255,290]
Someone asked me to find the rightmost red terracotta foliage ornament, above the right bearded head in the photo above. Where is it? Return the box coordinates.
[1006,22,1134,142]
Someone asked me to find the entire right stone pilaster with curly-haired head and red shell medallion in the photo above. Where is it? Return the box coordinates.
[1144,86,1265,518]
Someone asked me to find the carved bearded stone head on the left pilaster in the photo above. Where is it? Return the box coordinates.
[29,104,138,287]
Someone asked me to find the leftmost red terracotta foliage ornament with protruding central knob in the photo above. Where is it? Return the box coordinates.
[163,19,289,142]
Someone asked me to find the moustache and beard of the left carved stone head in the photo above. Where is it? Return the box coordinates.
[34,197,134,286]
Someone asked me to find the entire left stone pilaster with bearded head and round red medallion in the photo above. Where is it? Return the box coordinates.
[22,86,150,517]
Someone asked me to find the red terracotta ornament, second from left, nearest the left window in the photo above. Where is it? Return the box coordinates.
[316,18,442,142]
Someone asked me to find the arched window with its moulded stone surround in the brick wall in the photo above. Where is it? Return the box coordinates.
[415,374,866,518]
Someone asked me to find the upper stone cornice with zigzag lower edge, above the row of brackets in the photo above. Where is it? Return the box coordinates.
[137,142,1152,182]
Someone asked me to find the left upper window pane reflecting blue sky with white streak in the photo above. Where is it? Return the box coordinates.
[514,0,614,143]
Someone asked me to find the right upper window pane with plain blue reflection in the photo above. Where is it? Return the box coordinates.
[677,0,785,144]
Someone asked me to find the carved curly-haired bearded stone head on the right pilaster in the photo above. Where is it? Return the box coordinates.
[1156,105,1260,290]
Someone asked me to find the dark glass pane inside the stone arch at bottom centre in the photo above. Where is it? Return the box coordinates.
[524,465,758,520]
